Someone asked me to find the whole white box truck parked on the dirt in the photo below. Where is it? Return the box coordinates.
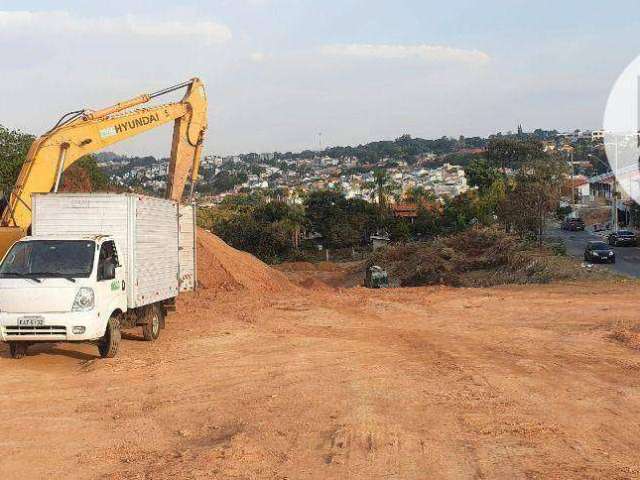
[0,194,197,358]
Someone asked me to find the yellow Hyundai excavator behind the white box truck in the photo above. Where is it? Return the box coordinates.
[0,78,207,258]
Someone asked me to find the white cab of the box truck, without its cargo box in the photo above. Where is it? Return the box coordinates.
[0,235,127,357]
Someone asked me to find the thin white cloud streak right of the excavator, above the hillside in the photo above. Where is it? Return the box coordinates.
[320,43,490,63]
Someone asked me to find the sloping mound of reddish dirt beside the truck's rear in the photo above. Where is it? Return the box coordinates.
[196,228,295,294]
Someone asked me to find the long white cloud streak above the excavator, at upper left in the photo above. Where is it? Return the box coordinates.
[0,10,231,45]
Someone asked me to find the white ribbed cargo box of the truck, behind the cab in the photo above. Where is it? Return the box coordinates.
[32,193,195,308]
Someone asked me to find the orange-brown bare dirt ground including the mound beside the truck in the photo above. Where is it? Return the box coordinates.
[0,232,640,480]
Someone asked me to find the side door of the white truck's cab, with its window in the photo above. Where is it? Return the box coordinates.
[96,240,126,318]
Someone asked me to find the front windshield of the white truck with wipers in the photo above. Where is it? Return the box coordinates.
[0,240,96,278]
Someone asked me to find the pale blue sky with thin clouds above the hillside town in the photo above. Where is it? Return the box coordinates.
[0,0,640,155]
